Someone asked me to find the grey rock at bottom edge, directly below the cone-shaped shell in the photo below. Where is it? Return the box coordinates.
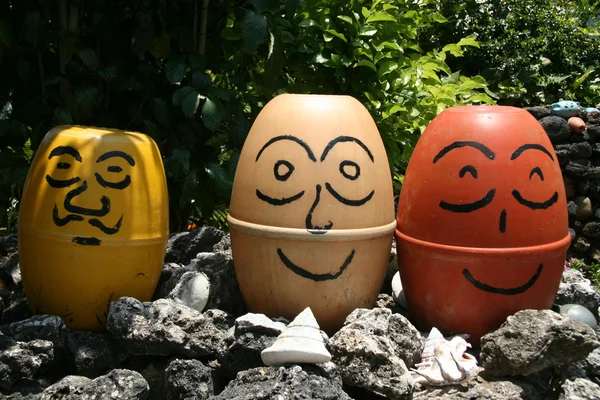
[210,365,352,400]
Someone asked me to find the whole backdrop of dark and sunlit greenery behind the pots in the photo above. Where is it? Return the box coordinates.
[0,0,600,231]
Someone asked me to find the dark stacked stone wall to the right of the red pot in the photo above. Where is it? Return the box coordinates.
[525,106,600,263]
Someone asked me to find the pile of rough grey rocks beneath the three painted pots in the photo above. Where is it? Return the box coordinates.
[0,227,600,400]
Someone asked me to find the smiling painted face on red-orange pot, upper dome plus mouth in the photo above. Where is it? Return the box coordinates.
[398,107,568,295]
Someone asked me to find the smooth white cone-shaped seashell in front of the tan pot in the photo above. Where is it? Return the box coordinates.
[260,307,331,366]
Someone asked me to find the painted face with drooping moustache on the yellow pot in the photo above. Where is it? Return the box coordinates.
[21,127,166,246]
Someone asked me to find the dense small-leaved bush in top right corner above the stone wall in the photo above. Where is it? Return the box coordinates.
[422,0,600,106]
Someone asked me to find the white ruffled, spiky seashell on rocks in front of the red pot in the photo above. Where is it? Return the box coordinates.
[411,327,482,386]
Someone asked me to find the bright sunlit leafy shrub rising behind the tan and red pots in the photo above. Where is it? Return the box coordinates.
[281,0,494,183]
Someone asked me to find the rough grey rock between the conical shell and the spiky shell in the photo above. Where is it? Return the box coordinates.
[330,309,423,399]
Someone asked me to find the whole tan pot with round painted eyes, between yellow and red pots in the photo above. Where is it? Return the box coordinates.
[228,94,394,333]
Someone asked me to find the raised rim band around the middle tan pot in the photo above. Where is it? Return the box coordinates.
[227,214,396,242]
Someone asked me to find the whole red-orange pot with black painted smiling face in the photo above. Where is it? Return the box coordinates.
[396,106,570,346]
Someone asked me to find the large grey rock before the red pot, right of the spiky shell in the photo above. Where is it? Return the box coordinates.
[480,310,600,376]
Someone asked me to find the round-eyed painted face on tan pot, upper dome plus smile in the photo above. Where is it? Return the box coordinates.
[231,95,393,281]
